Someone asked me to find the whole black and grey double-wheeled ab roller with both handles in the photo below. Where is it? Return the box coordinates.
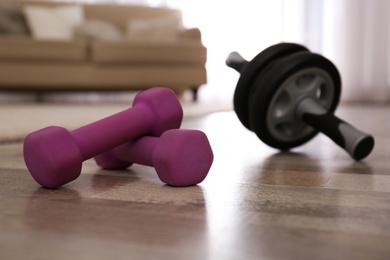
[226,43,374,160]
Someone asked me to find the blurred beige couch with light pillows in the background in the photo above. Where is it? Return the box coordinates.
[0,0,207,99]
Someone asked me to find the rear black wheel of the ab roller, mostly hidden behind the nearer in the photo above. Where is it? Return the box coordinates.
[233,43,309,129]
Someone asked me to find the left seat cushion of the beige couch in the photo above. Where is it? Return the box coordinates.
[0,37,87,61]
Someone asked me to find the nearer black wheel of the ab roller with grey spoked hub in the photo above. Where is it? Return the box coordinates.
[248,52,341,150]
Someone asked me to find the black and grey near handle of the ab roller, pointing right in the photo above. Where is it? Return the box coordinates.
[296,97,374,160]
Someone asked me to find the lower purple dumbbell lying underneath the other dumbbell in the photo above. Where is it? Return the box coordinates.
[95,129,214,186]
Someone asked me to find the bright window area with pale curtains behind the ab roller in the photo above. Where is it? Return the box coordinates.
[0,0,390,103]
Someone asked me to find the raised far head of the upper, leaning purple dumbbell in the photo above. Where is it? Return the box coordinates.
[133,87,183,136]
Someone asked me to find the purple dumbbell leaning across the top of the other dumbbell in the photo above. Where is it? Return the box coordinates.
[23,88,183,188]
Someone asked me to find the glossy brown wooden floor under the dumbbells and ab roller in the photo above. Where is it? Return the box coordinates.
[0,104,390,259]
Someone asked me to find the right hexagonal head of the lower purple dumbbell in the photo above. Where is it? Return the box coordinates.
[153,130,214,187]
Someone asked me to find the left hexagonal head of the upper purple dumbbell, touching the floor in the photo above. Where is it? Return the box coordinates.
[23,126,83,188]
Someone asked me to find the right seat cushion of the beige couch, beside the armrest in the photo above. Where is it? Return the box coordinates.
[91,41,207,64]
